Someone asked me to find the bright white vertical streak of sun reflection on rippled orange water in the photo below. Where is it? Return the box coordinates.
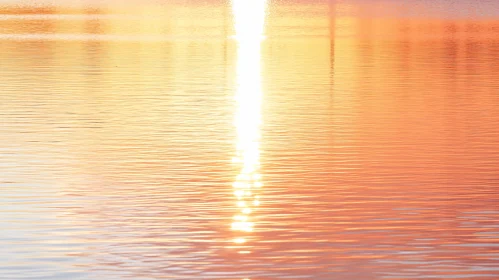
[232,0,267,247]
